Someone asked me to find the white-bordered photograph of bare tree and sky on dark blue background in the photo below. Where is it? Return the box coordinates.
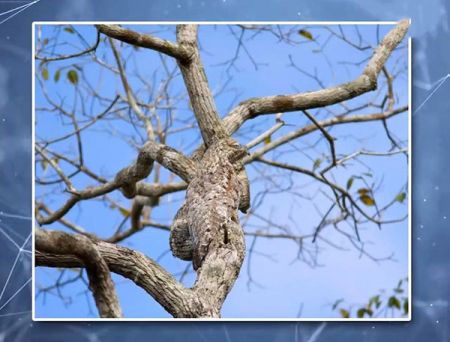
[32,20,412,321]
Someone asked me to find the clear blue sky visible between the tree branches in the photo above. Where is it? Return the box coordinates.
[36,26,407,317]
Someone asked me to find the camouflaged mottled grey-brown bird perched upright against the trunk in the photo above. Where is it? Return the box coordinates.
[190,139,246,269]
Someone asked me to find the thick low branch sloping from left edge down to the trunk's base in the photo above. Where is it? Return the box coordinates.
[35,228,193,317]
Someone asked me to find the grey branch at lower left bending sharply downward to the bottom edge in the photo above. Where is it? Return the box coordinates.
[35,228,122,318]
